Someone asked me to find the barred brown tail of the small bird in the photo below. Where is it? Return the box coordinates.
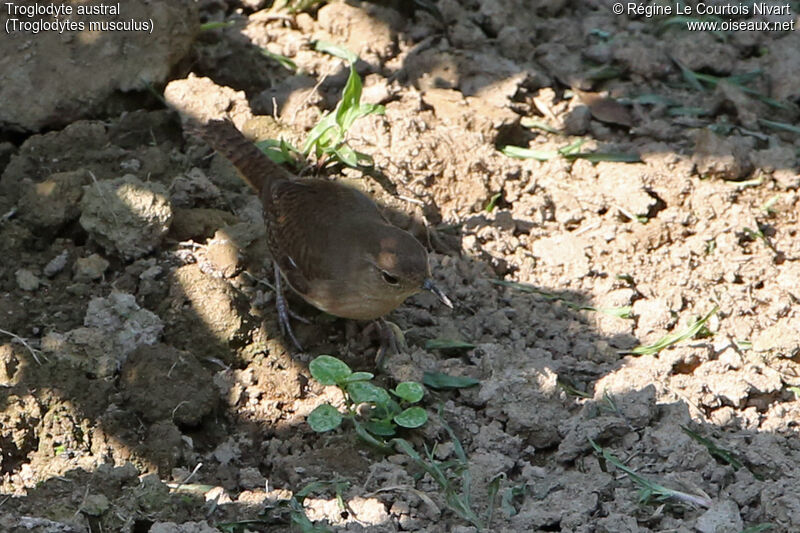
[189,120,292,195]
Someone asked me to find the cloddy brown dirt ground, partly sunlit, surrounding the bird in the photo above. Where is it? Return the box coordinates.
[0,0,800,533]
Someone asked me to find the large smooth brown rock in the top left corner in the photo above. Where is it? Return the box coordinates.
[0,0,199,132]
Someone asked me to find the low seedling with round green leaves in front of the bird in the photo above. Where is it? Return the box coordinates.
[308,355,428,451]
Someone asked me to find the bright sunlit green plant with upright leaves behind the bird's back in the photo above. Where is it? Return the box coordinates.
[302,41,385,167]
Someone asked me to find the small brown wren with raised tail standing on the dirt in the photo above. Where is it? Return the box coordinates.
[193,120,453,358]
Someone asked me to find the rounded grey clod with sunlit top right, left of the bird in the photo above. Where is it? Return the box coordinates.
[80,174,172,260]
